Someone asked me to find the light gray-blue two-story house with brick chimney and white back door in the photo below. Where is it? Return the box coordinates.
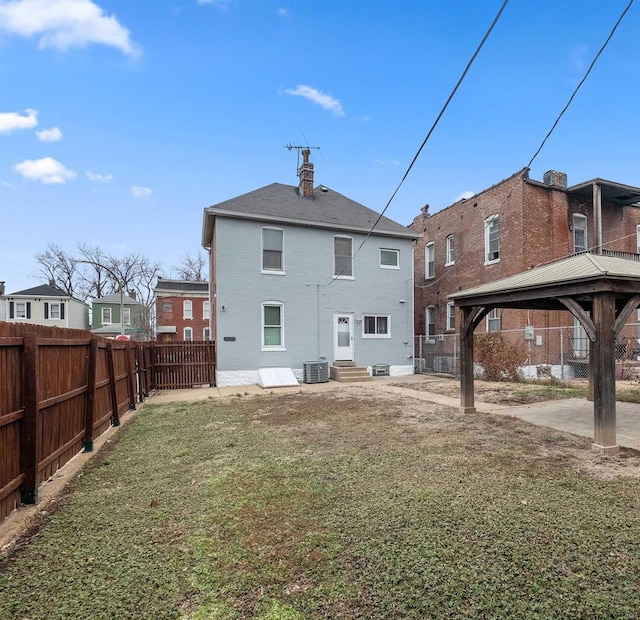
[202,150,417,386]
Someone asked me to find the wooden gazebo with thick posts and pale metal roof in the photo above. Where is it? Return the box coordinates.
[449,253,640,453]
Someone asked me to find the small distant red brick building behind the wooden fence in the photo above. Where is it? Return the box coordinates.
[153,278,211,342]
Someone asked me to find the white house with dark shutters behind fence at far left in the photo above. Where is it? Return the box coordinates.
[0,284,89,329]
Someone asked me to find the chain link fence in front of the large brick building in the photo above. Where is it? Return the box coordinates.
[415,323,640,380]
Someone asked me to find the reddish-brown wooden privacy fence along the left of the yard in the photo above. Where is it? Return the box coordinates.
[0,322,215,521]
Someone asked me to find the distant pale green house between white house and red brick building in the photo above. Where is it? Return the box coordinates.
[91,291,146,340]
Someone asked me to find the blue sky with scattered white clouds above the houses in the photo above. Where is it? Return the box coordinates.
[0,0,640,292]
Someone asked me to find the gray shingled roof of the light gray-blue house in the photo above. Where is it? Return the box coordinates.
[202,183,419,247]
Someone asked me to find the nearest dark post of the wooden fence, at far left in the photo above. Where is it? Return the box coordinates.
[20,332,42,504]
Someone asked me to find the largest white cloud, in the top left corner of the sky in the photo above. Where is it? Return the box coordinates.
[0,0,139,56]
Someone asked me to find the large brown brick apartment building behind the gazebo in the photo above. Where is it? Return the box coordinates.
[411,169,640,370]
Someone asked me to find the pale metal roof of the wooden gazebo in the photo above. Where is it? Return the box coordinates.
[449,253,640,305]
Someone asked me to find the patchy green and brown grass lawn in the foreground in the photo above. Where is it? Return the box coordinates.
[0,387,640,620]
